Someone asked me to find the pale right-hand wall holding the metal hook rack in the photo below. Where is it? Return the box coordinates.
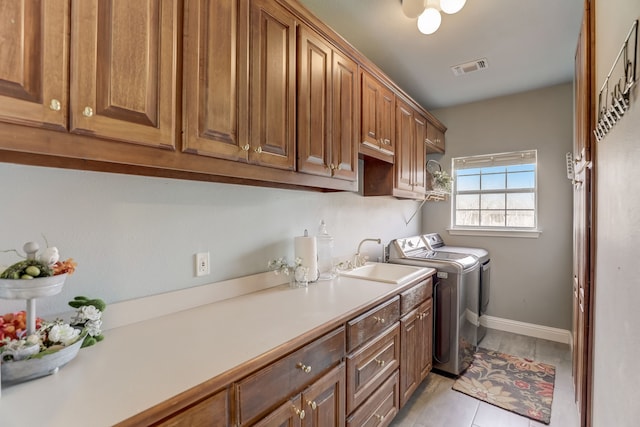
[593,0,640,427]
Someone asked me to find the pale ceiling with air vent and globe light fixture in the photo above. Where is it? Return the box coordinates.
[299,0,583,109]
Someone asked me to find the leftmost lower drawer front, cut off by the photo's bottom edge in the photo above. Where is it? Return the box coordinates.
[154,390,229,427]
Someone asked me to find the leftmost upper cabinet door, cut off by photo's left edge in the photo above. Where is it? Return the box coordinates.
[0,0,69,130]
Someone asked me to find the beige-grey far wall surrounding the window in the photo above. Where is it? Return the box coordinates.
[422,84,573,330]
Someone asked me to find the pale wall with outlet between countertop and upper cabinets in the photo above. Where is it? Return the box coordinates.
[0,163,420,317]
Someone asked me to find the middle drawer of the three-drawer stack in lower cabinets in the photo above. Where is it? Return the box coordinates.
[347,322,400,413]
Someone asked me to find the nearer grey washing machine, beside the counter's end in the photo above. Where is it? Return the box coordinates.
[387,236,480,376]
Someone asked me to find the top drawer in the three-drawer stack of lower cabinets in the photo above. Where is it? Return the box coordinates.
[347,296,400,352]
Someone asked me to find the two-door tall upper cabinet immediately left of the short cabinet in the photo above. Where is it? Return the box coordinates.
[297,26,358,181]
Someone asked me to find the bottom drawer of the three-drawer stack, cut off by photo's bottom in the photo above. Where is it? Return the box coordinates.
[347,371,400,427]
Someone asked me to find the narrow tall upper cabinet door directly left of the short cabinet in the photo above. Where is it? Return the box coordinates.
[329,50,359,181]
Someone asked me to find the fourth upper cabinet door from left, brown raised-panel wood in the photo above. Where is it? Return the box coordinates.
[249,0,297,170]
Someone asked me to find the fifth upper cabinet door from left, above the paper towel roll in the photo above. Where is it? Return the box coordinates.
[297,25,332,176]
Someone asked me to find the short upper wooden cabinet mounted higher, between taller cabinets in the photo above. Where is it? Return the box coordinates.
[360,70,396,163]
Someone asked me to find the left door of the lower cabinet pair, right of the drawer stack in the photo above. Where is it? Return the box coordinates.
[400,309,422,408]
